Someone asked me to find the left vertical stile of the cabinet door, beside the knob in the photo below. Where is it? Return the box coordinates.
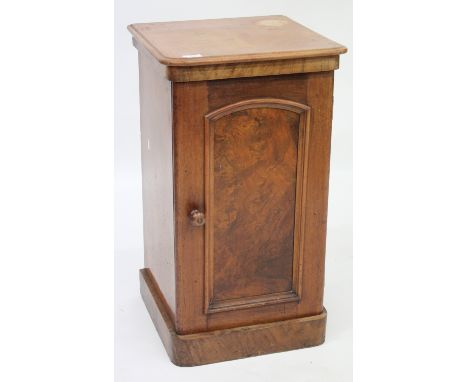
[172,82,208,334]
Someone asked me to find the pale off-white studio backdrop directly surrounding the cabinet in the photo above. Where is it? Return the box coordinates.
[115,0,353,382]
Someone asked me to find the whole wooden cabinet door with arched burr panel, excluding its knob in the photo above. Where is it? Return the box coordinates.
[173,72,333,333]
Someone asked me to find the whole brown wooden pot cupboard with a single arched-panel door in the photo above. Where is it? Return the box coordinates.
[128,16,346,366]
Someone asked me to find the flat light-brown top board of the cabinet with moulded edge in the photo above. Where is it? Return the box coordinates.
[128,16,347,66]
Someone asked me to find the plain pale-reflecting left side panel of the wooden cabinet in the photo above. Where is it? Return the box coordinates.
[139,52,176,313]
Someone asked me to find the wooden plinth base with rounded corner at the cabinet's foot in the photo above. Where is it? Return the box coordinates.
[140,268,327,366]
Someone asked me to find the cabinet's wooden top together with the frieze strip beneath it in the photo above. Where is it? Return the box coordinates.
[128,16,346,82]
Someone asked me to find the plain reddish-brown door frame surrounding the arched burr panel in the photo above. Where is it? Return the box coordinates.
[173,71,333,334]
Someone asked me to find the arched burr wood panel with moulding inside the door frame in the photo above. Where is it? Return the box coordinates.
[205,98,310,313]
